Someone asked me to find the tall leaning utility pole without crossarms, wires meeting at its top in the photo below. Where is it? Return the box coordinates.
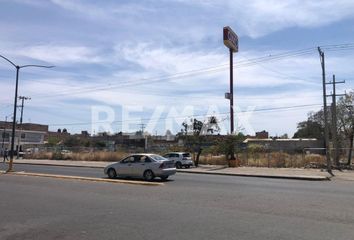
[318,47,333,175]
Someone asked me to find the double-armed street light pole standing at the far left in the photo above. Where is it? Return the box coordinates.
[0,55,54,172]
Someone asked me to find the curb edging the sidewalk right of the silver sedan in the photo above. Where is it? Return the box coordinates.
[178,170,331,181]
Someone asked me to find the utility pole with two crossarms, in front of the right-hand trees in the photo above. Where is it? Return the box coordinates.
[327,75,345,168]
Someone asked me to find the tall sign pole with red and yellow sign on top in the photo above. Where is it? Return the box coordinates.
[223,26,238,134]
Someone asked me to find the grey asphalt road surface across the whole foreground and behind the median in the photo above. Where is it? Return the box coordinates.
[0,164,354,240]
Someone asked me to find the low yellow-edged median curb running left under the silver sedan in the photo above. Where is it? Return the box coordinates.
[1,172,165,186]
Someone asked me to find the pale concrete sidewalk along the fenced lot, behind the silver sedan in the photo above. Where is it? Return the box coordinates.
[9,159,354,181]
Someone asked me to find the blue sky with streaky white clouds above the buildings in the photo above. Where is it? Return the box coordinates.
[0,0,354,135]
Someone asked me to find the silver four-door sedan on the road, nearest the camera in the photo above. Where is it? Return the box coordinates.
[104,153,176,181]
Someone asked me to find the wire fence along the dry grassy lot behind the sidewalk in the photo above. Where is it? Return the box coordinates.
[24,147,354,168]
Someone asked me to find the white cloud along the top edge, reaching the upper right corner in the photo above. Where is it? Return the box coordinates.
[176,0,354,38]
